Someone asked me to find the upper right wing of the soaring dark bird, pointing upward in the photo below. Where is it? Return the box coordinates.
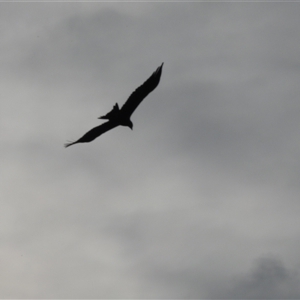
[121,63,164,118]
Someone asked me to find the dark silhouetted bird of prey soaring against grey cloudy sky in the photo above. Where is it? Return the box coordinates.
[65,63,164,147]
